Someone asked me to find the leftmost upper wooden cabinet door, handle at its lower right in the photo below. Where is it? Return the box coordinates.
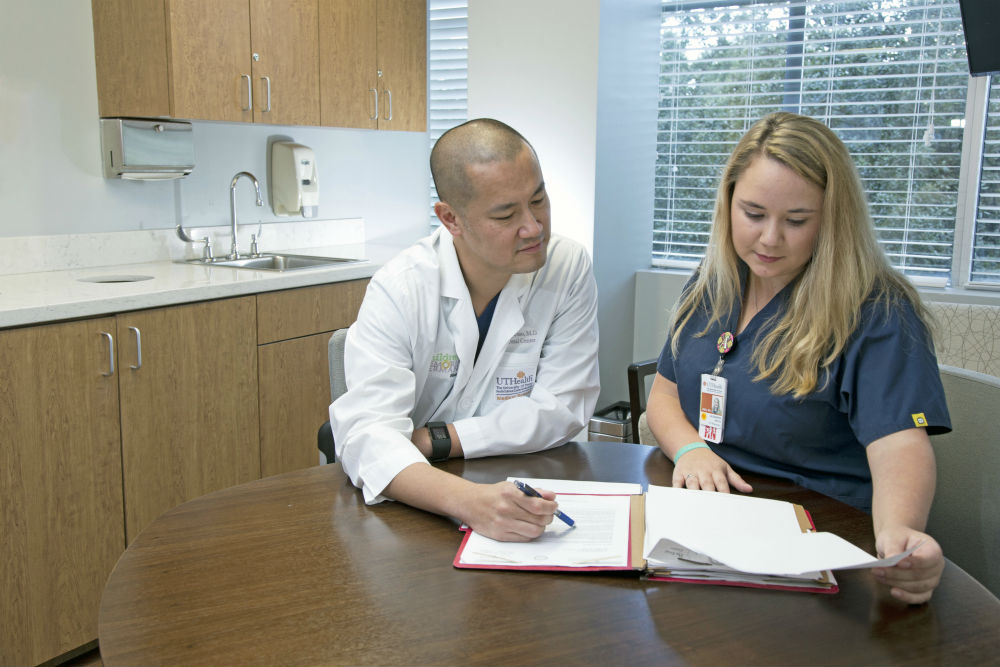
[167,0,259,122]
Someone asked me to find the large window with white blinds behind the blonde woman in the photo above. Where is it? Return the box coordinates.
[652,0,1000,286]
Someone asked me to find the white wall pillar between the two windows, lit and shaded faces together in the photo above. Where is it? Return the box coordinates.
[469,0,660,407]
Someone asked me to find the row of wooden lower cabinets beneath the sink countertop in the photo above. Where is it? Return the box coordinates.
[0,279,368,665]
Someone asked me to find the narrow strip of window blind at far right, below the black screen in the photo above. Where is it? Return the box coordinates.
[971,76,1000,284]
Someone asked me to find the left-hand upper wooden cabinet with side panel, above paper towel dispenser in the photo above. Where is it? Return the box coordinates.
[92,0,319,125]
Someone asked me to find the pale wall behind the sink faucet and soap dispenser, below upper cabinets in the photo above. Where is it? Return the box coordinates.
[0,0,429,245]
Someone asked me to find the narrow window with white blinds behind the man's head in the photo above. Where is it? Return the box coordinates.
[427,0,469,226]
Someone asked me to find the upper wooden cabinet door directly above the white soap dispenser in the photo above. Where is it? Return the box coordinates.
[250,0,320,125]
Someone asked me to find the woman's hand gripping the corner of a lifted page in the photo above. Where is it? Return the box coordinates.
[872,526,944,604]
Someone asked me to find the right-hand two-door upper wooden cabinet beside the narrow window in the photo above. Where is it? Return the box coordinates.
[319,0,427,132]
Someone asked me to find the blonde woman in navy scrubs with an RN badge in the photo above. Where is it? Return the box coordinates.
[647,113,951,603]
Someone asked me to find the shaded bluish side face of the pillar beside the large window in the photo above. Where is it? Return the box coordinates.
[594,0,660,406]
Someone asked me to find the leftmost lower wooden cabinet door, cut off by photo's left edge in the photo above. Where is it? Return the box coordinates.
[0,317,125,665]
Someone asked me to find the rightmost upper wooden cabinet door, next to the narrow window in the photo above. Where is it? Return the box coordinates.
[378,0,427,132]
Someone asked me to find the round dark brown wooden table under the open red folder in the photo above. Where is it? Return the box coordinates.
[99,443,1000,667]
